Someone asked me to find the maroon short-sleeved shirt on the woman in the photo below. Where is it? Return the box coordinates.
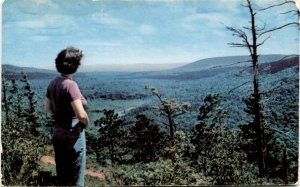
[46,77,87,127]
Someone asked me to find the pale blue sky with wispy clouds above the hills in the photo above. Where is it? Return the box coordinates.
[2,0,299,68]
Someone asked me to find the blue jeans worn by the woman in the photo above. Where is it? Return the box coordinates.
[52,121,86,186]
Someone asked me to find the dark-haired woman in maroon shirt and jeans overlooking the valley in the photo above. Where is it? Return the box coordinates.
[44,47,89,186]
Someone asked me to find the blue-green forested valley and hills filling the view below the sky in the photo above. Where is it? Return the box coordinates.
[1,55,299,186]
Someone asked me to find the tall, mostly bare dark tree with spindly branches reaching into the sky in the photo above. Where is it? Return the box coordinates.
[227,0,299,177]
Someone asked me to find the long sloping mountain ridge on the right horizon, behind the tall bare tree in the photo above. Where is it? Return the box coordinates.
[134,55,299,80]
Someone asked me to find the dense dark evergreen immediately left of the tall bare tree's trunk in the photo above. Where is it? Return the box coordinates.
[191,94,257,185]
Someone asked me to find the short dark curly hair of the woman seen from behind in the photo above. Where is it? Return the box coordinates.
[55,47,83,74]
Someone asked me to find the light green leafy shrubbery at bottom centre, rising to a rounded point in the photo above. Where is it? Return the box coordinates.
[113,131,212,186]
